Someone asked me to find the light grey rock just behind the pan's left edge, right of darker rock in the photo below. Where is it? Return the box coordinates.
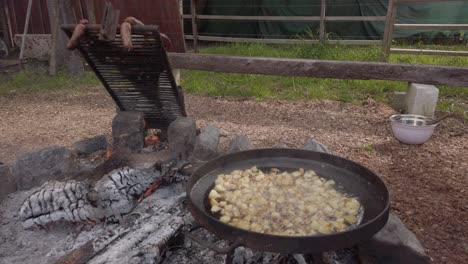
[192,125,220,160]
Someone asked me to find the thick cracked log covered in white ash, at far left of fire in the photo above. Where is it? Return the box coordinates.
[19,163,178,228]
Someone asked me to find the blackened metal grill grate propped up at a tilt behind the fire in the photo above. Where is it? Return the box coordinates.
[62,25,186,129]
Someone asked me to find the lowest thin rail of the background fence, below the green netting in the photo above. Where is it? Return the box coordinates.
[185,35,382,45]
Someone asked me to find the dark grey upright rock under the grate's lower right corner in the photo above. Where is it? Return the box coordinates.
[167,117,197,159]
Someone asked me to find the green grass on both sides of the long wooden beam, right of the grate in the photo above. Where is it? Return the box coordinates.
[182,43,468,112]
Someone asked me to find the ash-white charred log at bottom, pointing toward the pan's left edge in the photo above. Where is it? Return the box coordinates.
[55,194,185,264]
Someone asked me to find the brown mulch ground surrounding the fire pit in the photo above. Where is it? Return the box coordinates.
[0,89,468,263]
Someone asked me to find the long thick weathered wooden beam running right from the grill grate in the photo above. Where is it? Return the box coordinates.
[169,53,468,86]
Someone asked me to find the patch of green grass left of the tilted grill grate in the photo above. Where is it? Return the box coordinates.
[0,66,99,96]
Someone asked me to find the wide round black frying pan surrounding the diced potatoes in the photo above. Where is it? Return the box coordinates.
[187,149,389,254]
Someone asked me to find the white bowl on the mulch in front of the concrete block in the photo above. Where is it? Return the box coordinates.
[390,115,437,144]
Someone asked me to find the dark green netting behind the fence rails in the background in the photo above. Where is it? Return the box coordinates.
[185,0,468,39]
